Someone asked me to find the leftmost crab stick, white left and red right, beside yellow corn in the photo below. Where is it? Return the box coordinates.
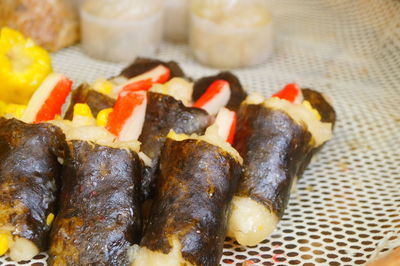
[22,73,72,123]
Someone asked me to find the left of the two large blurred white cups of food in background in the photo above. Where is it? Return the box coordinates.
[80,0,163,62]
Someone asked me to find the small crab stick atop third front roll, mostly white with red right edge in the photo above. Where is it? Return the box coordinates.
[215,108,236,144]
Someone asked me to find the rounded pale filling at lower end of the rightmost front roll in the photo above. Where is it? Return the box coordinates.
[228,196,279,246]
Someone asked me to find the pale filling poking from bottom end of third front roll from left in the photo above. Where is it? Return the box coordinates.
[132,239,192,266]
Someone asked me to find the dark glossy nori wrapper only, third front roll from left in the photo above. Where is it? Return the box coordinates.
[141,139,241,265]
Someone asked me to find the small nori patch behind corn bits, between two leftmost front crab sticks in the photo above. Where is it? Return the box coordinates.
[64,83,116,120]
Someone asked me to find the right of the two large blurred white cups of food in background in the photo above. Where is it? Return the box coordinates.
[189,0,273,69]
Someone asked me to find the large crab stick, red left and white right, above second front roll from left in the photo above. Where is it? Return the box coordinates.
[106,91,147,141]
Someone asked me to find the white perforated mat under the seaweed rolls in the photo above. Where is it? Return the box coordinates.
[0,0,400,266]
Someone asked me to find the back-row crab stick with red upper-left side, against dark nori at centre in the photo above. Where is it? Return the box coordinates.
[193,79,231,115]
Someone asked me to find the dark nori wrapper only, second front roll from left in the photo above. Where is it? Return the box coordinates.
[49,140,142,265]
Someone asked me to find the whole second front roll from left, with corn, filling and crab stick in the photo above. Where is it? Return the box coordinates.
[49,98,146,265]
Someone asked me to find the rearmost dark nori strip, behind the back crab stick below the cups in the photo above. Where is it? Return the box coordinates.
[120,57,185,79]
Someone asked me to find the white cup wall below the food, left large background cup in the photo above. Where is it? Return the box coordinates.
[80,9,163,62]
